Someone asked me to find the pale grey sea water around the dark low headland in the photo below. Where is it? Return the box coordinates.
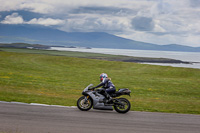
[51,47,200,69]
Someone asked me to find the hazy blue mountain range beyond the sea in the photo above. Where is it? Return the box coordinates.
[0,24,200,52]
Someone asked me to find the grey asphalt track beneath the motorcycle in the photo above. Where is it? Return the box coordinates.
[0,102,200,133]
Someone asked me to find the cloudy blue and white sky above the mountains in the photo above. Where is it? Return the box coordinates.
[0,0,200,47]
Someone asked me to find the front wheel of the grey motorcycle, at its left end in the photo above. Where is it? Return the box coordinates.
[77,96,92,111]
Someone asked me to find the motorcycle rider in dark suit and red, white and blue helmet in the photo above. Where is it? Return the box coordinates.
[93,73,116,102]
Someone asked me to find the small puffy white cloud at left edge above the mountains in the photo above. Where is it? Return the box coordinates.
[1,13,24,24]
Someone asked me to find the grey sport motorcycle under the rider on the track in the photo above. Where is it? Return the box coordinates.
[77,84,131,113]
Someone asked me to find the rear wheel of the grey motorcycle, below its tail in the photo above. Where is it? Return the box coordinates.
[114,98,131,113]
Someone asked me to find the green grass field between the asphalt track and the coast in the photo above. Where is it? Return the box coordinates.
[0,49,200,114]
